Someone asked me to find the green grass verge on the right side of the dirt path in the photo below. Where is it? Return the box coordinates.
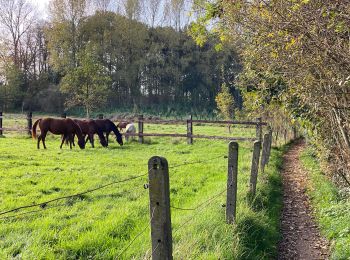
[300,149,350,259]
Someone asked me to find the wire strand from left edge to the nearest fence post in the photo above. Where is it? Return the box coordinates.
[0,173,148,216]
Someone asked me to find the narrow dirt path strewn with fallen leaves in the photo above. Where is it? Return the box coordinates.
[278,141,329,260]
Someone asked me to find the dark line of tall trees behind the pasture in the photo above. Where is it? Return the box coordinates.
[0,0,240,115]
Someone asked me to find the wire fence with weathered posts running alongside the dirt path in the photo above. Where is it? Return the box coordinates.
[0,125,278,260]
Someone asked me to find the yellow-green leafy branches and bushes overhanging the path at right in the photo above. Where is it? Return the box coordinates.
[192,0,350,187]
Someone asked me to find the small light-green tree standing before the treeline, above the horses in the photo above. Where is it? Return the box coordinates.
[61,45,110,118]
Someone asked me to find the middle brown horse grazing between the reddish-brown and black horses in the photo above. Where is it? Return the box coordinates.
[70,119,108,148]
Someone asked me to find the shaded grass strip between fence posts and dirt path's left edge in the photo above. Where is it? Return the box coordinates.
[236,144,291,259]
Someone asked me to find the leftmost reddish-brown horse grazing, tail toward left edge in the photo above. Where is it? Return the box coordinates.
[32,118,85,149]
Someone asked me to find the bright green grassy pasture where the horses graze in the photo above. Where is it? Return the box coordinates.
[0,116,283,259]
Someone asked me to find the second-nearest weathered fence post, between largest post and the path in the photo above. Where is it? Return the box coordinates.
[226,141,238,224]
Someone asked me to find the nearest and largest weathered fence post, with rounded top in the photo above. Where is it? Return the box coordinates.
[148,156,173,260]
